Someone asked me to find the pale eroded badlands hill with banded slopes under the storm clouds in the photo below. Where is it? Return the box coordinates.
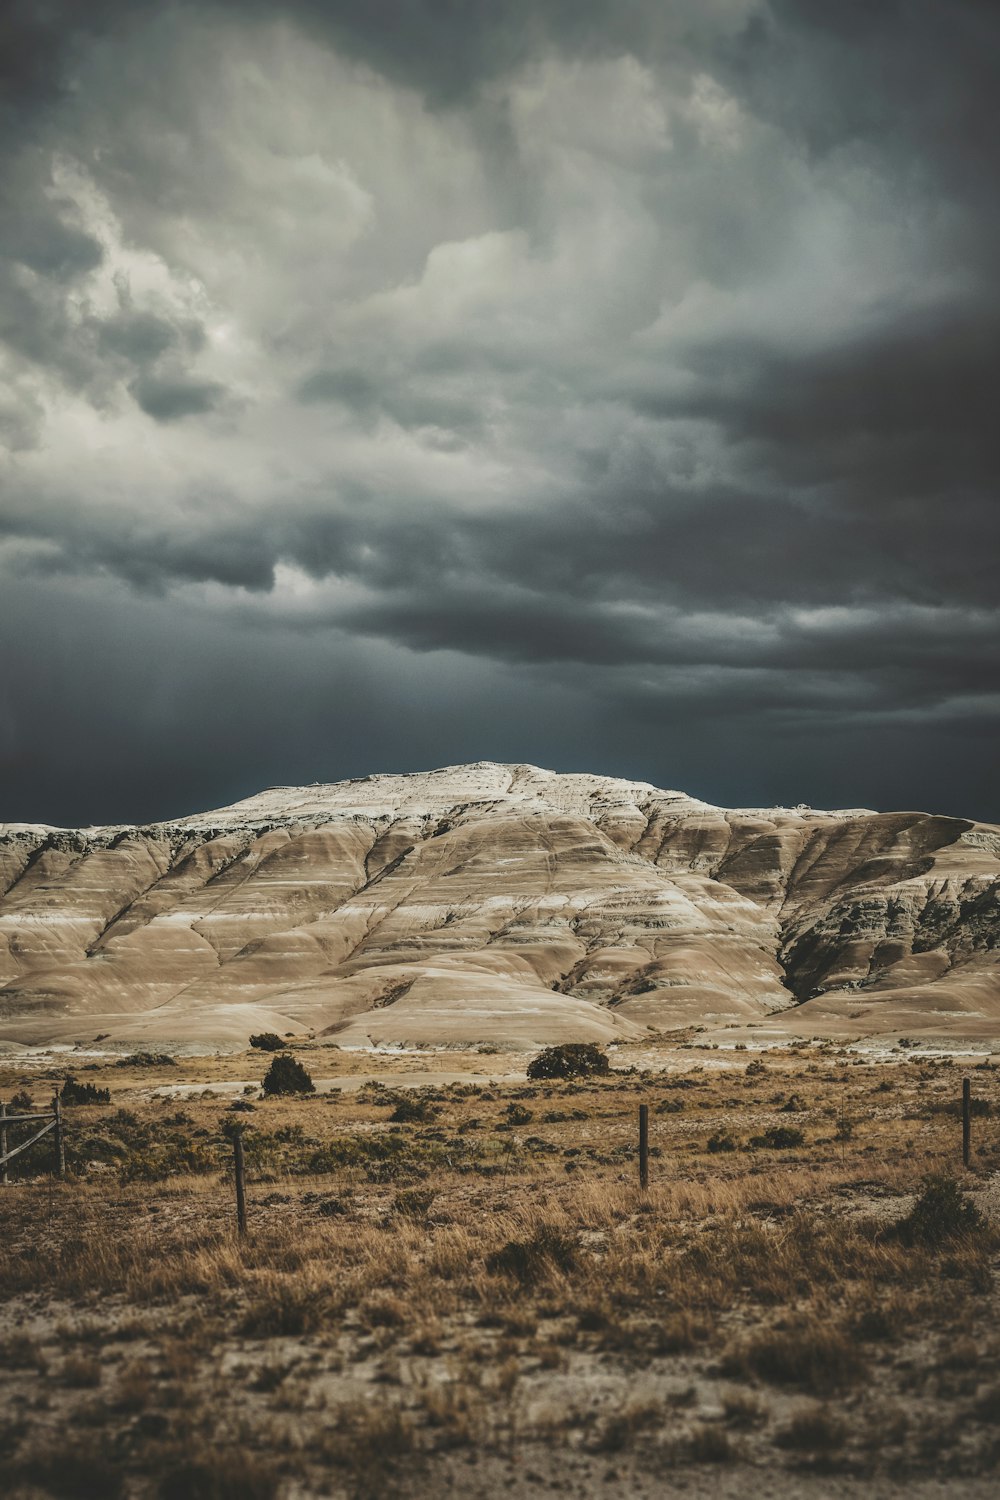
[0,764,1000,1046]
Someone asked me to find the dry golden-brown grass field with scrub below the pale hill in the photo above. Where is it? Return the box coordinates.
[0,1037,1000,1500]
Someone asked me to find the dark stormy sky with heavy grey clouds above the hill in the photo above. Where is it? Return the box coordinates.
[0,0,1000,825]
